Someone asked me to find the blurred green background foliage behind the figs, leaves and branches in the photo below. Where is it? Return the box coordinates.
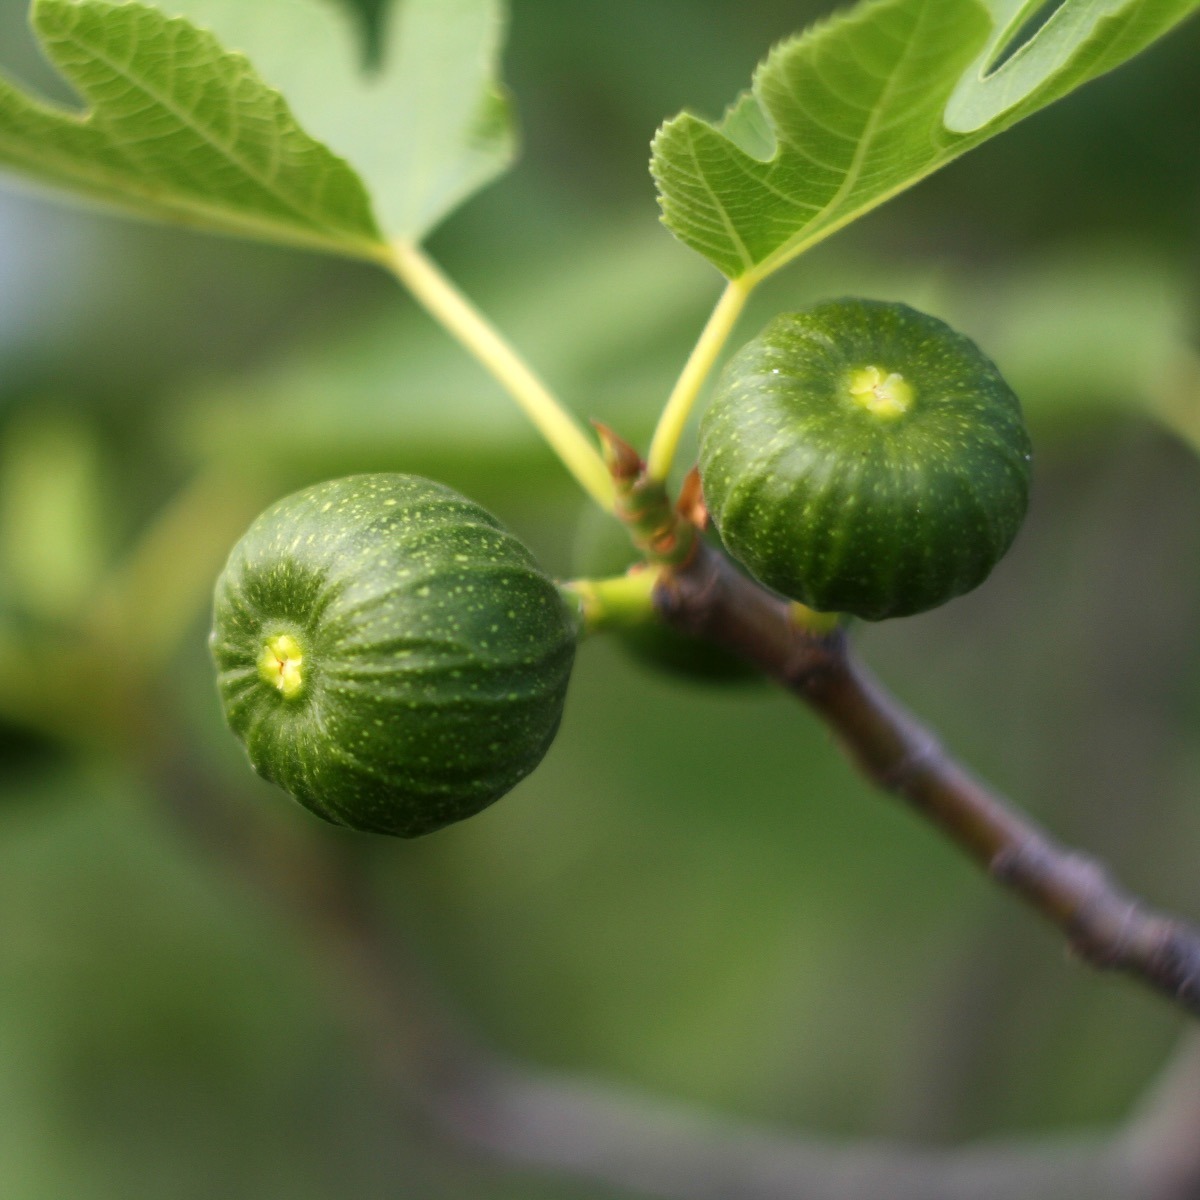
[0,0,1200,1200]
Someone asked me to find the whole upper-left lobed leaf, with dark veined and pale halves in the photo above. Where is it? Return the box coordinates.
[0,0,515,258]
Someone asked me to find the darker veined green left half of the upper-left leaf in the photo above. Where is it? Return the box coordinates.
[0,0,382,257]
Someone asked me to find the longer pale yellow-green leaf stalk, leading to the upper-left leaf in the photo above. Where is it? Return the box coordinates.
[388,241,613,512]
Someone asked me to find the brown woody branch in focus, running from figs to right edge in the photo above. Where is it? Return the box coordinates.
[655,540,1200,1015]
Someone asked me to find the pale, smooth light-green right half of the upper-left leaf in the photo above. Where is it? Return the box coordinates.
[146,0,516,242]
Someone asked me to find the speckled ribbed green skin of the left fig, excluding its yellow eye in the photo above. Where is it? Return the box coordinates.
[211,474,576,838]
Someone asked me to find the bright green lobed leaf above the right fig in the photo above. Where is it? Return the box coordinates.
[650,0,1200,281]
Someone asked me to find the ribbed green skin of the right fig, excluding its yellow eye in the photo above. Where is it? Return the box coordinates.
[700,299,1032,620]
